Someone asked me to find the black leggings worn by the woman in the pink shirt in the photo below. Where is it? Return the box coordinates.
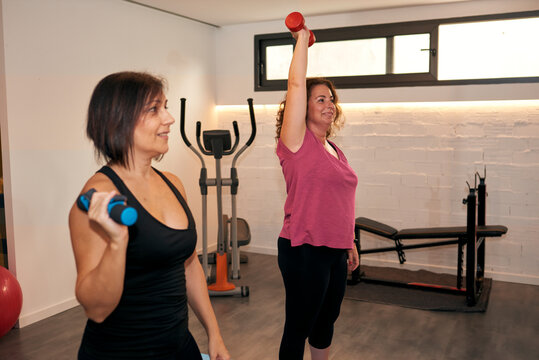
[278,238,348,360]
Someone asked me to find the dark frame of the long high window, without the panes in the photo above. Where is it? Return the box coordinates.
[254,10,539,91]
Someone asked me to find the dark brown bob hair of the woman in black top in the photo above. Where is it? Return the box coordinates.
[86,71,166,167]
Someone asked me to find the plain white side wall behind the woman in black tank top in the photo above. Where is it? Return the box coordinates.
[1,0,216,326]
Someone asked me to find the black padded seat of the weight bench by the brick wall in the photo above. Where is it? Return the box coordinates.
[356,217,507,240]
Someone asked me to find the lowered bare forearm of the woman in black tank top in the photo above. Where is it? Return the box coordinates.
[185,251,230,360]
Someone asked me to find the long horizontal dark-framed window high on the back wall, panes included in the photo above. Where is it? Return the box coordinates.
[255,11,539,91]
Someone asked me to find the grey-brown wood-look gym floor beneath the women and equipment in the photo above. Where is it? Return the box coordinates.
[0,254,539,360]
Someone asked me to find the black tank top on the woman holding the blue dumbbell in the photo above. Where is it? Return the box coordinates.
[79,166,197,359]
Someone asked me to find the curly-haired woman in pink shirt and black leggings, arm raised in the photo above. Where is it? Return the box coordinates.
[276,28,359,360]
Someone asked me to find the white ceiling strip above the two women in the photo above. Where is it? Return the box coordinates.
[125,0,474,27]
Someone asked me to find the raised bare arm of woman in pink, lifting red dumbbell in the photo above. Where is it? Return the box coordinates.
[280,28,310,152]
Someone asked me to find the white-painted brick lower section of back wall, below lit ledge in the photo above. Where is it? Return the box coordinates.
[218,101,539,284]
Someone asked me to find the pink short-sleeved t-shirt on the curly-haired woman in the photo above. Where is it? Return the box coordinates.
[276,129,357,249]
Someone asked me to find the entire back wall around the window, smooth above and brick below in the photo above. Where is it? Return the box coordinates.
[217,1,539,284]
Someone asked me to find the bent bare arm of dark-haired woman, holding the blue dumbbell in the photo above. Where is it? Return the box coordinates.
[69,178,128,322]
